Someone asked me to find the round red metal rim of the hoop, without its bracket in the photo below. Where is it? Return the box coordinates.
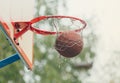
[30,16,87,35]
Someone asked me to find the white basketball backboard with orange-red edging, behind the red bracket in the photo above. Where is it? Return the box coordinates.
[0,0,34,69]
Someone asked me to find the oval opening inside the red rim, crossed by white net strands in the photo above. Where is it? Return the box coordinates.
[33,18,84,32]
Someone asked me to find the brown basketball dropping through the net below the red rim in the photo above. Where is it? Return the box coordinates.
[55,31,83,58]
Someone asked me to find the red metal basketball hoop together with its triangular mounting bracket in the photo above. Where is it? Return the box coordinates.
[12,16,86,40]
